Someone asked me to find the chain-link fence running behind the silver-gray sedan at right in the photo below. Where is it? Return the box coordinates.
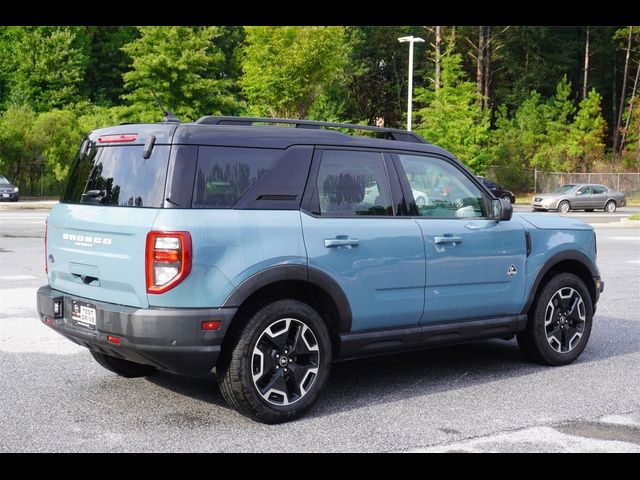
[485,165,640,197]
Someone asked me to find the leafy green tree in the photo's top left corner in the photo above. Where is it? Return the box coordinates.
[0,27,88,111]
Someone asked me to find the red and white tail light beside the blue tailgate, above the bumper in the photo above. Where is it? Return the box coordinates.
[146,231,192,294]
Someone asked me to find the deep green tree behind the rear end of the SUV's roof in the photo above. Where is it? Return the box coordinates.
[122,27,236,121]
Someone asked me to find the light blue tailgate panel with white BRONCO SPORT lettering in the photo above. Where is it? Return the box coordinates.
[47,204,158,308]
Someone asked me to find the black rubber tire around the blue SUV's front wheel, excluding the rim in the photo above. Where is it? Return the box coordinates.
[518,273,593,365]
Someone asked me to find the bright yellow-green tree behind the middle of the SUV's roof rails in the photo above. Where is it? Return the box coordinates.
[240,26,349,118]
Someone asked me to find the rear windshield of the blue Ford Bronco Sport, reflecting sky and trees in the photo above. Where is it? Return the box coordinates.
[62,145,169,208]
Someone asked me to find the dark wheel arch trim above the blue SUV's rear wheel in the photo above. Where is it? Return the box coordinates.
[221,265,352,333]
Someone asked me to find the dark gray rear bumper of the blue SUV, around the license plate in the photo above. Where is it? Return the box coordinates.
[37,285,237,375]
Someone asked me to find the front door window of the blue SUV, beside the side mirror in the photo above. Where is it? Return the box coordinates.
[398,155,487,218]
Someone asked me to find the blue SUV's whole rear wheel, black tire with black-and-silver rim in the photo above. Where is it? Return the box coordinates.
[216,300,331,424]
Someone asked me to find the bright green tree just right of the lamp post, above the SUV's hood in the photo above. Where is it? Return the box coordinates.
[416,54,489,174]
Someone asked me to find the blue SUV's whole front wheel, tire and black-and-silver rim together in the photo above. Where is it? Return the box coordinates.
[517,273,593,366]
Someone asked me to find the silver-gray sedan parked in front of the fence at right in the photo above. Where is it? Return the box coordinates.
[531,183,626,213]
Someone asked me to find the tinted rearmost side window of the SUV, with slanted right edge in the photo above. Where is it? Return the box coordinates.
[193,147,282,208]
